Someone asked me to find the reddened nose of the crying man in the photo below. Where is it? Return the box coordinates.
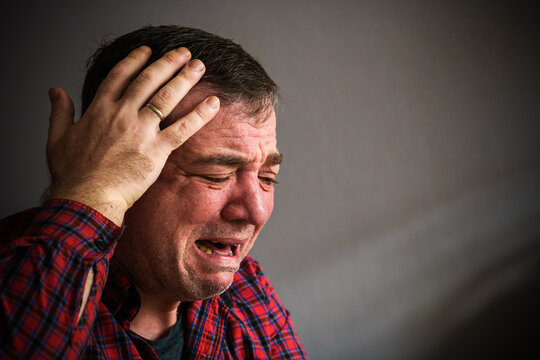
[221,175,274,226]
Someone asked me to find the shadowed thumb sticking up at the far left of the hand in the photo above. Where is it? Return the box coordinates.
[47,88,75,148]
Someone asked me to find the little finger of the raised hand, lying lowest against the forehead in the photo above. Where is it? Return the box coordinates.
[159,96,219,151]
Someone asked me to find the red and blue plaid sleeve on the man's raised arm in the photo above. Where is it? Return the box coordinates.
[0,200,122,359]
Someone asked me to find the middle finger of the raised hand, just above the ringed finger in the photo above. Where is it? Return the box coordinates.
[123,47,191,109]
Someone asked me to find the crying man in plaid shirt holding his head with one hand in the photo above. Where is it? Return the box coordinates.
[0,26,305,359]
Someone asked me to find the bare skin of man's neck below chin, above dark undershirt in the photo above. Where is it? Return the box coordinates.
[130,290,180,341]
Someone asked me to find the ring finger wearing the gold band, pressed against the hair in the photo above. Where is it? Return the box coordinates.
[141,59,204,118]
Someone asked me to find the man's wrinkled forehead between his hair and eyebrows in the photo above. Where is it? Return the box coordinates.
[169,89,276,160]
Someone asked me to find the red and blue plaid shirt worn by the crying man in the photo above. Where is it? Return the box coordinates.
[0,200,305,359]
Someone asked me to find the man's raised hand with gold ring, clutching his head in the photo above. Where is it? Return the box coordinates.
[47,46,219,225]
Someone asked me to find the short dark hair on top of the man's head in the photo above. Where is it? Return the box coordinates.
[81,25,278,116]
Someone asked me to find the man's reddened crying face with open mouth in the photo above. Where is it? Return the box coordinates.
[116,89,281,301]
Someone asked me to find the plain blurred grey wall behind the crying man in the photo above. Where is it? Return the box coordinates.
[0,0,540,359]
